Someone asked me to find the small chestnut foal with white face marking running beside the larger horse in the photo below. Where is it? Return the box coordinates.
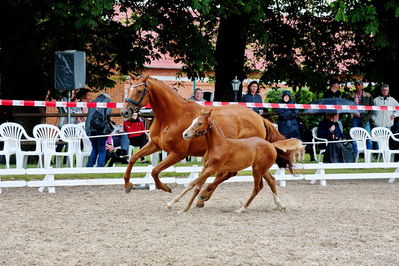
[166,108,302,212]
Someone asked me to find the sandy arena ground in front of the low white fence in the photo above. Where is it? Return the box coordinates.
[0,180,399,266]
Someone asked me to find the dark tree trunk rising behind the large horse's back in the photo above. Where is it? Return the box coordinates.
[214,15,248,101]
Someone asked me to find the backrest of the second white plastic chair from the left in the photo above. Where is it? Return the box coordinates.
[33,124,60,153]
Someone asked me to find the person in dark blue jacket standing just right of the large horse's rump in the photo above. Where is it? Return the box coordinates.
[276,91,301,139]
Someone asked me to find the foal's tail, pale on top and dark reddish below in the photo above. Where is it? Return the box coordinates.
[272,138,303,174]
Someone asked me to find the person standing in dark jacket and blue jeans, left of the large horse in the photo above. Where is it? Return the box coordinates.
[85,93,111,167]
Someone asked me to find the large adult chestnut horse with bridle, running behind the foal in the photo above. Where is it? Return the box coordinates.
[121,75,300,196]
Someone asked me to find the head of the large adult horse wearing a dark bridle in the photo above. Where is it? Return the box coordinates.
[121,74,150,118]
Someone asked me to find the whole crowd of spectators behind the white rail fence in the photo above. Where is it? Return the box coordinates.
[54,80,399,167]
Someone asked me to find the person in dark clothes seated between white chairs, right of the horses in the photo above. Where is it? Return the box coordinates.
[317,114,344,163]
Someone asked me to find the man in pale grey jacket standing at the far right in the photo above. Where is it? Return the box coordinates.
[372,84,399,129]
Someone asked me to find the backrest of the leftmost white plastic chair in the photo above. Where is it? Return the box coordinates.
[0,122,28,152]
